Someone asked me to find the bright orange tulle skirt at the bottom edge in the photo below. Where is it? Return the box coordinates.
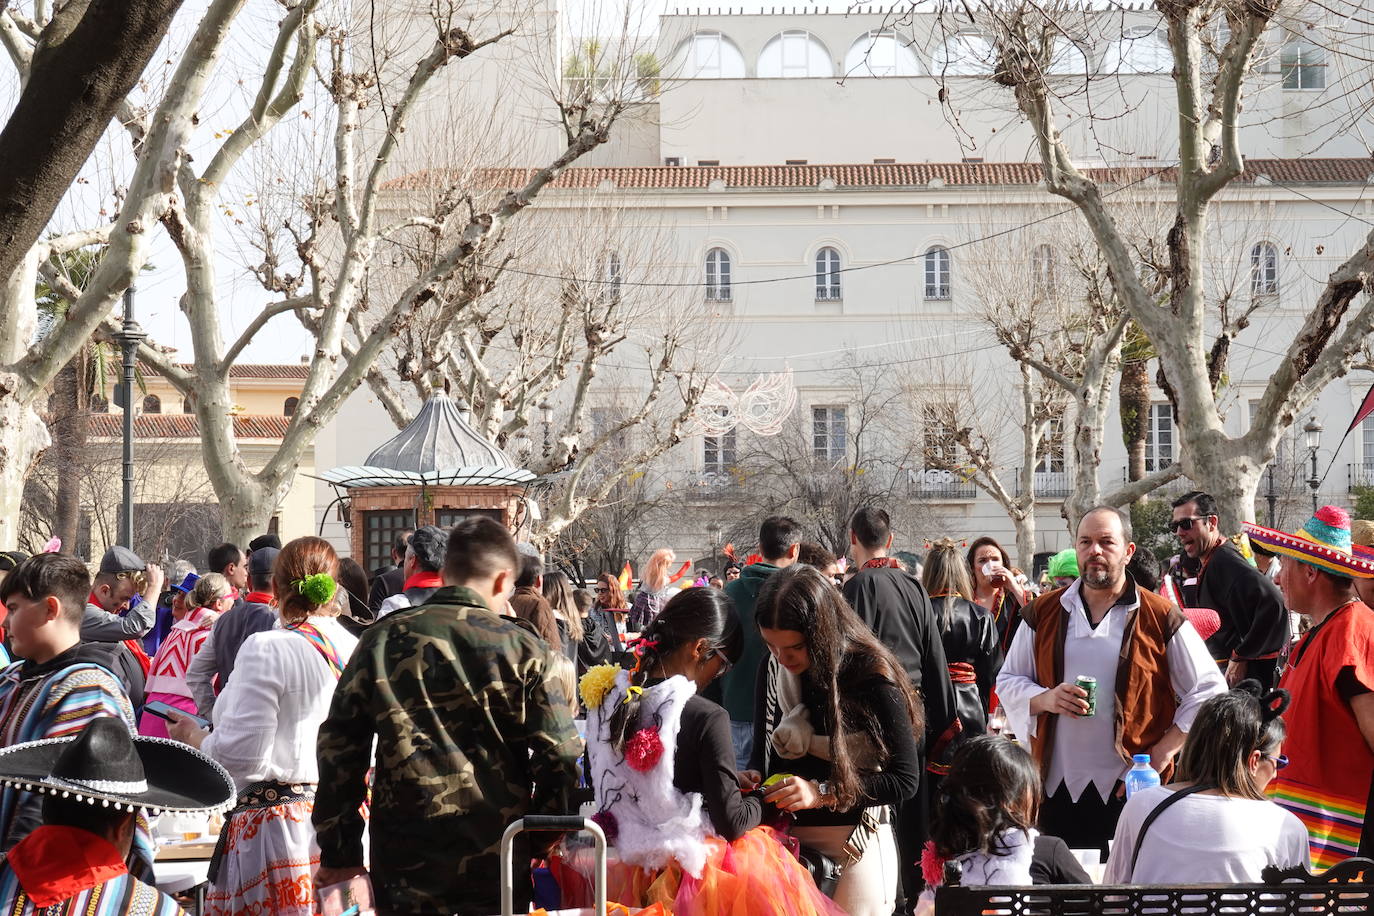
[606,827,845,916]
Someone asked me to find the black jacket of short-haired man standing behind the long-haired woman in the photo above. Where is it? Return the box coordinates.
[844,567,956,761]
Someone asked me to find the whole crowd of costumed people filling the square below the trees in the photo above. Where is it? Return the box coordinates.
[0,493,1374,916]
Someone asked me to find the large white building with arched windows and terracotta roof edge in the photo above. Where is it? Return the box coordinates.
[316,3,1374,574]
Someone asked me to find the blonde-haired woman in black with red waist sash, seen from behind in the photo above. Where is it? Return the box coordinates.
[922,537,1002,736]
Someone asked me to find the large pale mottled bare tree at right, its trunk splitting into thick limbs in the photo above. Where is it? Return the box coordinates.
[943,0,1374,530]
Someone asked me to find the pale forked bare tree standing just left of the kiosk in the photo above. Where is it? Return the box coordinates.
[18,0,656,542]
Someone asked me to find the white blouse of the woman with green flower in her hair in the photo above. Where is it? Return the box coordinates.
[201,617,357,791]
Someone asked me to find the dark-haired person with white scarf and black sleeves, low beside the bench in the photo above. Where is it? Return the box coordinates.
[916,735,1092,916]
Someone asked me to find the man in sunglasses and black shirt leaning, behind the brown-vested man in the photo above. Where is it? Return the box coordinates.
[1171,490,1289,688]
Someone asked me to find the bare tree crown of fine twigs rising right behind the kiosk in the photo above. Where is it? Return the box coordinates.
[361,194,723,538]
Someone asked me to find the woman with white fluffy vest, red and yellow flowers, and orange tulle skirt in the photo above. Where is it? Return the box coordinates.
[581,588,842,916]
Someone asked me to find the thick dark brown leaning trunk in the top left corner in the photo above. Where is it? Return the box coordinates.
[0,0,181,276]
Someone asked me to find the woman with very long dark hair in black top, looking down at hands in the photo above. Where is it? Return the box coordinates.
[746,564,925,916]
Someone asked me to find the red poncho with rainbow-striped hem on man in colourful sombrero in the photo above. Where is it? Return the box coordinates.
[1270,602,1374,869]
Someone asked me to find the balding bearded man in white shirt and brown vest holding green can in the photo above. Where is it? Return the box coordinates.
[998,507,1226,853]
